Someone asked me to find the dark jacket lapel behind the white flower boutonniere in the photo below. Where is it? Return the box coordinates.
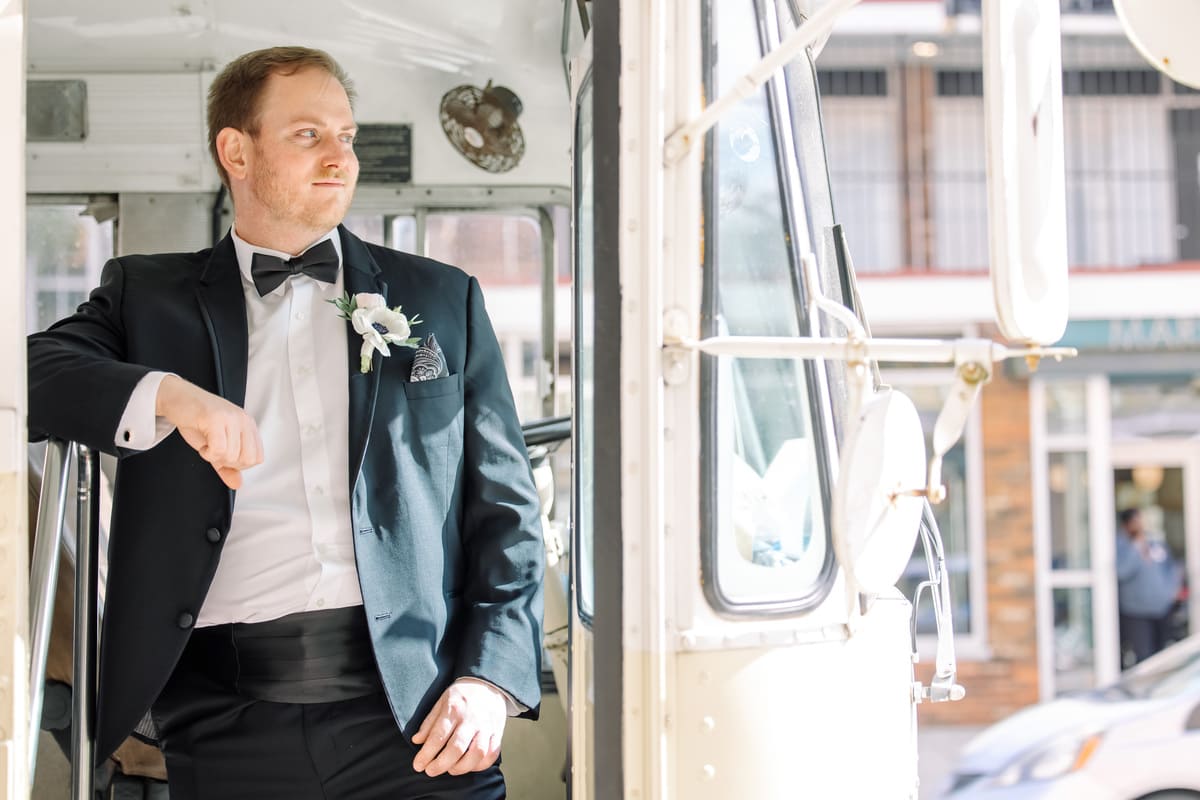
[338,221,388,495]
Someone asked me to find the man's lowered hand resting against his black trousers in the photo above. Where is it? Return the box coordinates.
[413,679,509,777]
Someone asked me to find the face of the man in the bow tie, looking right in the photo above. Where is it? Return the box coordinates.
[238,68,359,236]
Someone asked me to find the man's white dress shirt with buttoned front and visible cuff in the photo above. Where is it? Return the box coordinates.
[118,230,362,626]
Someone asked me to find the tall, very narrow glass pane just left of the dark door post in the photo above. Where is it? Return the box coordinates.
[575,76,595,619]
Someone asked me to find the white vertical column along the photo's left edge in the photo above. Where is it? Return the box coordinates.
[0,0,29,800]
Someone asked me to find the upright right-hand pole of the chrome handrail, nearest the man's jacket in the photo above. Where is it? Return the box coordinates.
[71,445,100,800]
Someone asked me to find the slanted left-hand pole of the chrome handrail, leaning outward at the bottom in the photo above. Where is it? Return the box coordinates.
[29,439,74,784]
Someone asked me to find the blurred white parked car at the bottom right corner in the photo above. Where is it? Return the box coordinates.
[940,634,1200,800]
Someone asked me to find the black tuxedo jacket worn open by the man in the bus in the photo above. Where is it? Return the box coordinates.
[29,228,544,759]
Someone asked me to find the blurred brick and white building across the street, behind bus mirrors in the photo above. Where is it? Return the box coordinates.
[817,0,1200,723]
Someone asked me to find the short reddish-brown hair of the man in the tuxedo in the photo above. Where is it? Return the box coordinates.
[209,47,355,187]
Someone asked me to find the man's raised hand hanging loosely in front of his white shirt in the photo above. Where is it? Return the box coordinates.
[155,375,263,489]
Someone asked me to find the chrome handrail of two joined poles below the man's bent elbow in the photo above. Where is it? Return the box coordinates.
[29,439,100,800]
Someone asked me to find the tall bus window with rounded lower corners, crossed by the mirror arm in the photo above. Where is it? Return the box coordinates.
[702,0,830,612]
